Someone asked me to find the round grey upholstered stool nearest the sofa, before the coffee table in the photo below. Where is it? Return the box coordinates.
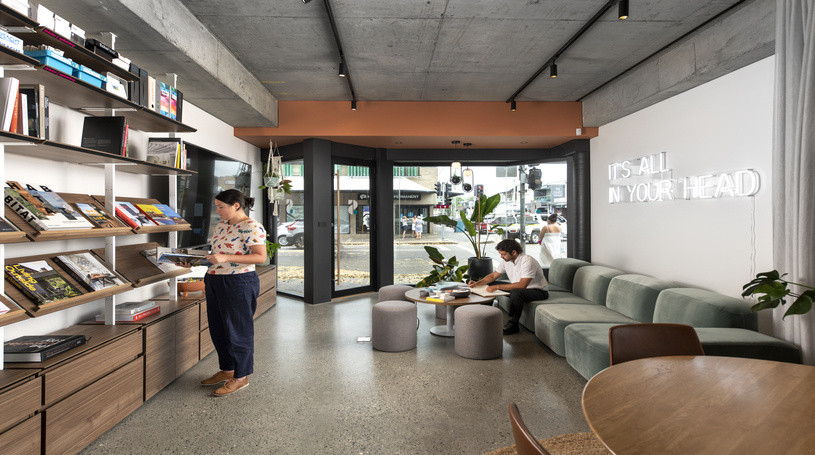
[455,305,504,360]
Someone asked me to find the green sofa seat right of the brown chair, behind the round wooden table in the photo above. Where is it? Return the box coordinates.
[696,327,801,363]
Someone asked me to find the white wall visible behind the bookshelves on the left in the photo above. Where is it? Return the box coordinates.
[3,102,262,341]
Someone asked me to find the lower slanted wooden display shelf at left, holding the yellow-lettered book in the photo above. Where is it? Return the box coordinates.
[5,250,133,317]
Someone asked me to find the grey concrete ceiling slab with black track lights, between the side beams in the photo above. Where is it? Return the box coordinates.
[181,0,737,101]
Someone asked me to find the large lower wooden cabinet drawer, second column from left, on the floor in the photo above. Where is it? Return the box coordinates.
[45,359,144,454]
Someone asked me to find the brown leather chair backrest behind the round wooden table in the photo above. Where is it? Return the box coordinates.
[608,324,705,365]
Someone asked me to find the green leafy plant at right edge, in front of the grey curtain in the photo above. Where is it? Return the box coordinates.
[741,270,815,317]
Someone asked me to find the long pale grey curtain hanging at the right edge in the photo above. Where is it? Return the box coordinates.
[773,0,815,365]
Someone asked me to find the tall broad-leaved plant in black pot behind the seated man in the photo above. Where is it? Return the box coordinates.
[425,193,501,280]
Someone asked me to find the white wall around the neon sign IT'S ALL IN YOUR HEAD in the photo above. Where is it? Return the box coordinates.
[591,57,775,297]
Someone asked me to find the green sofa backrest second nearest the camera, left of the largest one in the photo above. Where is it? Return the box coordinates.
[606,274,674,322]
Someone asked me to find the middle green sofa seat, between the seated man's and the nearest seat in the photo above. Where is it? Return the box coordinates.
[535,304,636,356]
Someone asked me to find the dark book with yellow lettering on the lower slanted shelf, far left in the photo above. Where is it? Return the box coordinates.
[6,261,81,305]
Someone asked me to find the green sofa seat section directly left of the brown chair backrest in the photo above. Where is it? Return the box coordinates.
[563,323,620,379]
